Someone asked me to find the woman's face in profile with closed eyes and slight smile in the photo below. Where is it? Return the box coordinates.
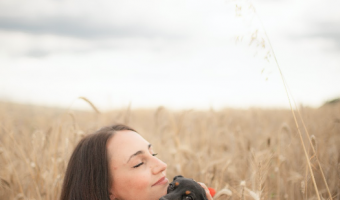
[107,130,168,200]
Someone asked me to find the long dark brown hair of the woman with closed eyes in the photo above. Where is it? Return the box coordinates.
[60,124,136,200]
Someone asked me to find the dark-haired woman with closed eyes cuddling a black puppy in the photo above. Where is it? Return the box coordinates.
[60,125,212,200]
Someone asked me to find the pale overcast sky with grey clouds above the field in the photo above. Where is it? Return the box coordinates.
[0,0,340,110]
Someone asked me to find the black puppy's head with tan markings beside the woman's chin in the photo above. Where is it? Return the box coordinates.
[159,175,208,200]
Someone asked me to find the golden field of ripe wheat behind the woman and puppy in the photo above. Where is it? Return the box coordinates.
[0,102,340,200]
